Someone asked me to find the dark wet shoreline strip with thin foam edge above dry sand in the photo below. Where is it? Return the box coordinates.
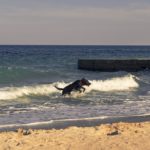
[0,114,150,132]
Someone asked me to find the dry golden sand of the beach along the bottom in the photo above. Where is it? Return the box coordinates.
[0,122,150,150]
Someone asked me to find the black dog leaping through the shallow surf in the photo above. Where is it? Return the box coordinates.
[55,78,91,95]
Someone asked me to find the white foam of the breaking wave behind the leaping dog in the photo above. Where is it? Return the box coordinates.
[0,75,138,100]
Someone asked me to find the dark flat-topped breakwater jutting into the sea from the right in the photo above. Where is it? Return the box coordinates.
[78,59,150,71]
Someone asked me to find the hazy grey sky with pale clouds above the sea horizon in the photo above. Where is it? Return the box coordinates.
[0,0,150,45]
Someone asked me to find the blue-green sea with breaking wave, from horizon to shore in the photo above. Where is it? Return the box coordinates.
[0,45,150,126]
